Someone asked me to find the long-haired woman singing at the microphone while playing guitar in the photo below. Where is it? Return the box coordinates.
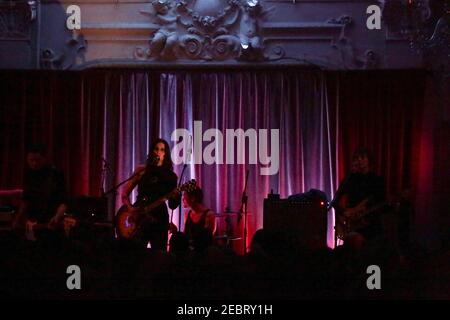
[121,139,180,251]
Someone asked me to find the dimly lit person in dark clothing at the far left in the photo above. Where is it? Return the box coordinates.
[13,145,67,240]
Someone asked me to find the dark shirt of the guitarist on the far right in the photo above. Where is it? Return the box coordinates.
[341,172,385,208]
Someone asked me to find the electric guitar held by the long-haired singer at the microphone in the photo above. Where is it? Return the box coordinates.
[115,179,197,239]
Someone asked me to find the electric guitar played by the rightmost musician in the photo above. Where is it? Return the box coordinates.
[334,199,391,239]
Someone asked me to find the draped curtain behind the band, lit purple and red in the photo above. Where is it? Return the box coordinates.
[0,69,426,250]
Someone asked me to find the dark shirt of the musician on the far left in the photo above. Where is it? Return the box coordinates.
[23,166,67,223]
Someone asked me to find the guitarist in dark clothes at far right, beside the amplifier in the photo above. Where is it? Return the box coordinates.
[332,148,385,240]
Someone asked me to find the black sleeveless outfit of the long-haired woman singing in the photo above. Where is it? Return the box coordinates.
[137,166,180,251]
